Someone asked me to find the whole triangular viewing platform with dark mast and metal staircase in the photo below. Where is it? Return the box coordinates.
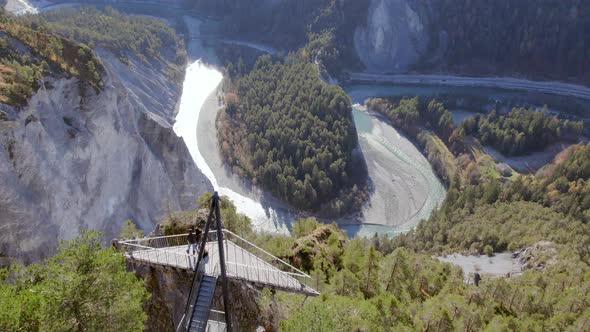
[114,193,319,332]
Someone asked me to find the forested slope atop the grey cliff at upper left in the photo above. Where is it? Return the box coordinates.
[0,7,186,106]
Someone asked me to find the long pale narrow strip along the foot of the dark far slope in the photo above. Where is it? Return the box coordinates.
[348,73,590,100]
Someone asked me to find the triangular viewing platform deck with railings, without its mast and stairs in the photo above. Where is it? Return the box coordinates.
[117,229,317,294]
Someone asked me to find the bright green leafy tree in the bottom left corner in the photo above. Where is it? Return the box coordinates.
[0,231,149,331]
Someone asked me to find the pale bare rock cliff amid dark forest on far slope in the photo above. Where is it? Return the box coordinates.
[354,0,429,73]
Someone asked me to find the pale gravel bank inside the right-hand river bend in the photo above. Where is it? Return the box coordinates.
[353,105,445,230]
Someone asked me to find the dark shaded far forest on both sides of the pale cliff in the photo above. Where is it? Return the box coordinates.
[188,0,590,83]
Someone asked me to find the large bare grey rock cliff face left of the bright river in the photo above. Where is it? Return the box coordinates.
[0,52,211,262]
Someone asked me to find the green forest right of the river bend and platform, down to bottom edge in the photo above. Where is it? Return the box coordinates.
[213,66,590,331]
